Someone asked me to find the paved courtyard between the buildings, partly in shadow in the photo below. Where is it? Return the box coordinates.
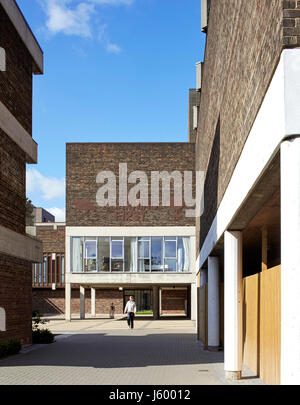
[0,317,262,385]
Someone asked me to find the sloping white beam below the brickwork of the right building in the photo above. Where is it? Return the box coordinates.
[196,48,300,271]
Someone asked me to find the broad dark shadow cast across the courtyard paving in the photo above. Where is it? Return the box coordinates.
[1,329,223,368]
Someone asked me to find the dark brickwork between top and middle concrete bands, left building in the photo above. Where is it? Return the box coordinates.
[0,5,32,134]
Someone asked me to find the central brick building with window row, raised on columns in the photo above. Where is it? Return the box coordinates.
[65,143,196,320]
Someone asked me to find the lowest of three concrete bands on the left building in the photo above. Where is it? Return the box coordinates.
[0,225,43,263]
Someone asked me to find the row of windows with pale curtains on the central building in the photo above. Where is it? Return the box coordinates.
[71,236,190,273]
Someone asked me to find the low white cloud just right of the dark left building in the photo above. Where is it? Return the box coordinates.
[26,169,65,200]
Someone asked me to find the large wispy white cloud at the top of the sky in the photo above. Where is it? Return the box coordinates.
[45,0,95,38]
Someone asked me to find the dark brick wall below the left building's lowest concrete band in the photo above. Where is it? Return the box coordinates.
[0,254,32,344]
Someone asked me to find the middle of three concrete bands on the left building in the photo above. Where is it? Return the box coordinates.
[0,100,37,163]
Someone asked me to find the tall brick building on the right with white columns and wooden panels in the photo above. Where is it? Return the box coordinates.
[196,0,300,384]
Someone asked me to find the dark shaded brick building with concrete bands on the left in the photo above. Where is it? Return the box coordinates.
[0,0,43,344]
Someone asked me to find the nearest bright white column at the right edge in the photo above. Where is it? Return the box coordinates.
[281,138,300,385]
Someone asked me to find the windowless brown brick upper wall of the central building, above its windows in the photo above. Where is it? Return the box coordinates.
[66,143,195,226]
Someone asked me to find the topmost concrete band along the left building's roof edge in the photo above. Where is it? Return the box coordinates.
[0,0,44,74]
